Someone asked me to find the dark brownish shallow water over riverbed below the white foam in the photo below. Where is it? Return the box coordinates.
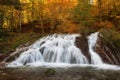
[0,67,120,80]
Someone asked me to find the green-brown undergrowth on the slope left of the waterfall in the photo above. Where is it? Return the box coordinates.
[0,32,45,54]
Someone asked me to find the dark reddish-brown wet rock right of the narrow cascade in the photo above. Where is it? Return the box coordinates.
[95,36,120,65]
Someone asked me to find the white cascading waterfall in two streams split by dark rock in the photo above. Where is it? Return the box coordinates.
[8,33,103,67]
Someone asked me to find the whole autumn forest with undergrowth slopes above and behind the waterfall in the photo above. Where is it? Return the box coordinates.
[0,0,120,54]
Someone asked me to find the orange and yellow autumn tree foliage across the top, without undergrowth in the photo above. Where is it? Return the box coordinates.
[0,0,120,36]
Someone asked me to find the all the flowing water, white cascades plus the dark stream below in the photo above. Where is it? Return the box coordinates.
[0,32,120,80]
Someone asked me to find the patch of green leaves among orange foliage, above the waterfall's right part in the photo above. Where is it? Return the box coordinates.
[73,0,93,26]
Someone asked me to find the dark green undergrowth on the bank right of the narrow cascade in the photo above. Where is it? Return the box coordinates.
[100,29,120,53]
